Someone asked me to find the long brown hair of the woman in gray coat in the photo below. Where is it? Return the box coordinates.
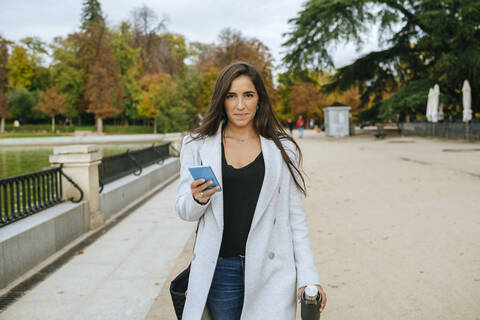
[192,61,307,195]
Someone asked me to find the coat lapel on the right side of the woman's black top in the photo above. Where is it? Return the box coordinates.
[250,136,282,232]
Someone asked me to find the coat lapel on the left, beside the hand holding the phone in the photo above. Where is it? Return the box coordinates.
[200,124,223,230]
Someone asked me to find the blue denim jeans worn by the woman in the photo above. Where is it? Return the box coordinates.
[207,257,245,320]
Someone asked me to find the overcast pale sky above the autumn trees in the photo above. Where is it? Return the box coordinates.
[0,0,375,72]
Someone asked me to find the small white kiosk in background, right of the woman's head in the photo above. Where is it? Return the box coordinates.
[323,102,351,137]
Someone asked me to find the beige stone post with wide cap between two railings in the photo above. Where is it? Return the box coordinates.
[50,145,104,230]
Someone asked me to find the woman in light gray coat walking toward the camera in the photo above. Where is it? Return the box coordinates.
[175,62,326,320]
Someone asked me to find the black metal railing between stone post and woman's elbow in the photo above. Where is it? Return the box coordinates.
[98,142,170,192]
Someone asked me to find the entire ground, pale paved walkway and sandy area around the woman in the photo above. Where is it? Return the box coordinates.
[0,131,480,320]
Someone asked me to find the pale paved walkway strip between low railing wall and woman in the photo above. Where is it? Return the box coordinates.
[0,179,195,320]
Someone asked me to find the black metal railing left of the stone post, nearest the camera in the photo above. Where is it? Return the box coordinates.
[0,167,83,227]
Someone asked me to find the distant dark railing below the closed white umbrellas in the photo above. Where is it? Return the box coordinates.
[401,121,480,141]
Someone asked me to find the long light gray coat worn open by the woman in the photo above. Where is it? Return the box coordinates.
[175,126,320,320]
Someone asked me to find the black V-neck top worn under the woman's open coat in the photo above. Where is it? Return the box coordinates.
[220,143,265,258]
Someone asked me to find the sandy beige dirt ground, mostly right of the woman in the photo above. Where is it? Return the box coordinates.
[147,131,480,320]
